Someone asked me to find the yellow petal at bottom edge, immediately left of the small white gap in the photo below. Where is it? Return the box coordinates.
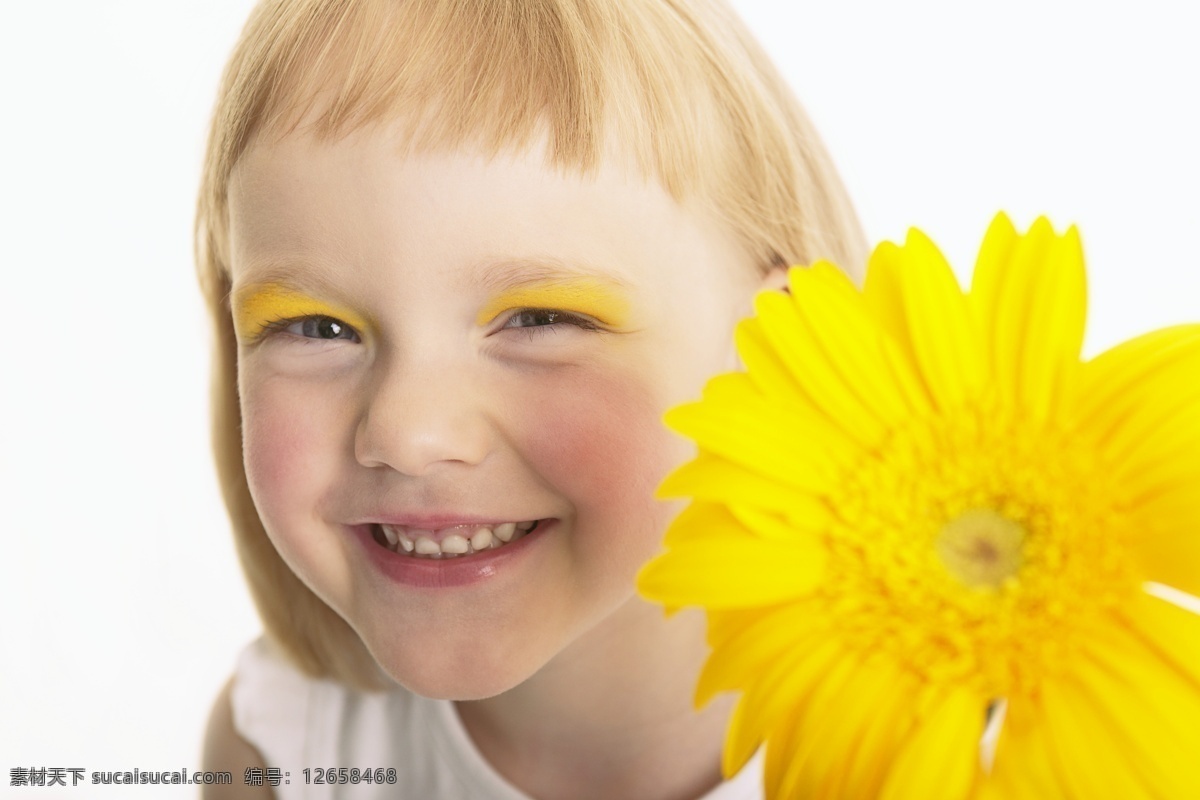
[880,686,985,800]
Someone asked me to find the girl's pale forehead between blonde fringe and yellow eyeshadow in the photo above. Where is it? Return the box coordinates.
[222,131,752,304]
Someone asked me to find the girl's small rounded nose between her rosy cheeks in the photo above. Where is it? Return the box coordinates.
[354,363,492,477]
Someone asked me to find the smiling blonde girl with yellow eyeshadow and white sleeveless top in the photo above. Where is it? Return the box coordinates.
[197,0,862,800]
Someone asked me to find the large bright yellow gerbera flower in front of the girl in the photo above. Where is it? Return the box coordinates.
[638,215,1200,800]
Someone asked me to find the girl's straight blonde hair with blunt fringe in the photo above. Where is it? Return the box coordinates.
[196,0,865,687]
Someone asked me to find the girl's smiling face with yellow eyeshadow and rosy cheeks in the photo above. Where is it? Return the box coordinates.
[230,132,761,699]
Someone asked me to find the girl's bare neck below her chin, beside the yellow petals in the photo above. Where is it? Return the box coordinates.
[457,599,732,800]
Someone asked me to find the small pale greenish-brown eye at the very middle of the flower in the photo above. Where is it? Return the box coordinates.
[935,509,1025,589]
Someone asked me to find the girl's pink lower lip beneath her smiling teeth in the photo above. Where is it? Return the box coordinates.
[350,519,549,589]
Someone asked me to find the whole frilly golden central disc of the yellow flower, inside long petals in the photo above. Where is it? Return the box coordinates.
[817,404,1140,698]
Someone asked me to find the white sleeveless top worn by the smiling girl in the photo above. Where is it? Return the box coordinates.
[232,639,763,800]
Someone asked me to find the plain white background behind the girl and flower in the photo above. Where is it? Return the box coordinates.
[0,0,1200,798]
